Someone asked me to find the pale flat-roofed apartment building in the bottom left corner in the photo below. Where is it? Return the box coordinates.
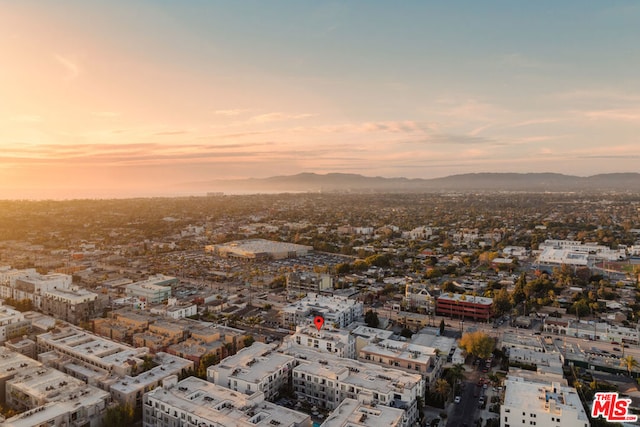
[2,366,111,427]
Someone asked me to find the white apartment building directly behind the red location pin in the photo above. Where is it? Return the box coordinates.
[282,292,364,328]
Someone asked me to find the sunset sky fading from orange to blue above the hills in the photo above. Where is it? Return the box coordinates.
[0,0,640,199]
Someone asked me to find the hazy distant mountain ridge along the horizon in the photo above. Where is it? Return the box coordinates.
[178,173,640,192]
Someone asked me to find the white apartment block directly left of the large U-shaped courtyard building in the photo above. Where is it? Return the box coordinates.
[207,342,296,401]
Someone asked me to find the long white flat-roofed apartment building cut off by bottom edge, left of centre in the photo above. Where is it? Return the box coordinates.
[142,377,312,427]
